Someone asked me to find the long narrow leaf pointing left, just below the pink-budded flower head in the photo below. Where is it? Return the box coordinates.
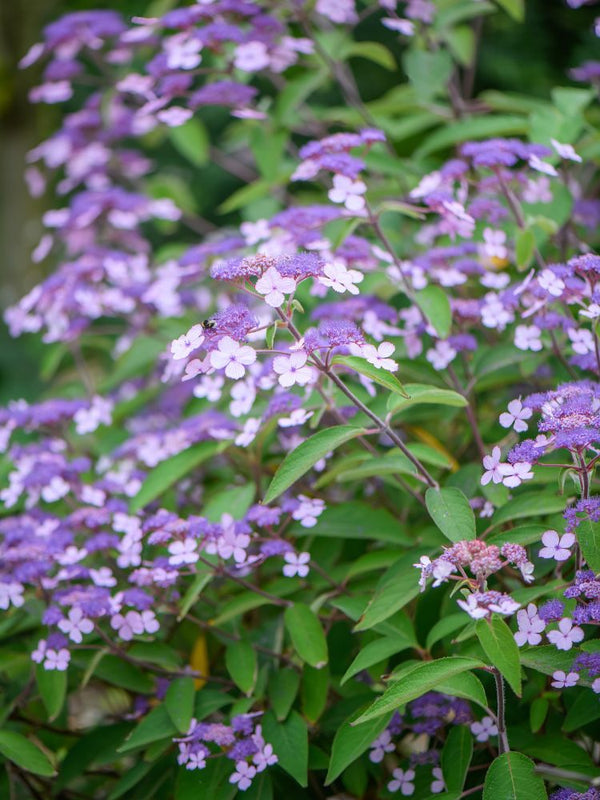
[356,656,484,724]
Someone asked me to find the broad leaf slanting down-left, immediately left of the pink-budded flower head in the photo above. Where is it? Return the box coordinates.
[355,550,428,631]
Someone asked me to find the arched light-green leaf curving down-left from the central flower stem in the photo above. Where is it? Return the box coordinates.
[264,425,366,504]
